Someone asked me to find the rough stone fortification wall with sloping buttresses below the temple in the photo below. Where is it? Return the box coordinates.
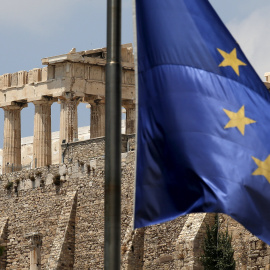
[0,135,270,270]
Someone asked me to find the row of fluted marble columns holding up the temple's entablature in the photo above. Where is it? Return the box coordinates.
[2,97,136,173]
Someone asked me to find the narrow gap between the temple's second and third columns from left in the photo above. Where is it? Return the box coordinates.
[51,102,61,164]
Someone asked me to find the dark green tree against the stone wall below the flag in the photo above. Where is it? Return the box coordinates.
[200,215,235,270]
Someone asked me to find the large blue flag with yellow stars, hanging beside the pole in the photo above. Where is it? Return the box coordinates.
[135,0,270,244]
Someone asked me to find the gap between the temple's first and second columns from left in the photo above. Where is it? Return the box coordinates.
[21,103,35,168]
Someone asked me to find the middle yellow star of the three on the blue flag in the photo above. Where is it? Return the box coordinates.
[223,105,256,135]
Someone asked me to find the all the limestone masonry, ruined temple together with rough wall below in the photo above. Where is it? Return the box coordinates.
[0,44,270,270]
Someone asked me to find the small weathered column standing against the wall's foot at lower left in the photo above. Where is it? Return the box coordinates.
[25,232,42,270]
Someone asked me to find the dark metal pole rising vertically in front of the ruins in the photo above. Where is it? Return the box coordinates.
[104,0,121,270]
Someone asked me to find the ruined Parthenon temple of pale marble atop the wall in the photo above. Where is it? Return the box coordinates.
[0,44,135,173]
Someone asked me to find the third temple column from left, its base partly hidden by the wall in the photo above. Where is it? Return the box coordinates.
[59,99,78,163]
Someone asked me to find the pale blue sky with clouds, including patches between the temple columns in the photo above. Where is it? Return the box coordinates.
[0,0,270,148]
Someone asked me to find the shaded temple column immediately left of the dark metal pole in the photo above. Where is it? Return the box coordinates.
[90,99,105,139]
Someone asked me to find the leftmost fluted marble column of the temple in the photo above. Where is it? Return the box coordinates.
[2,103,27,173]
